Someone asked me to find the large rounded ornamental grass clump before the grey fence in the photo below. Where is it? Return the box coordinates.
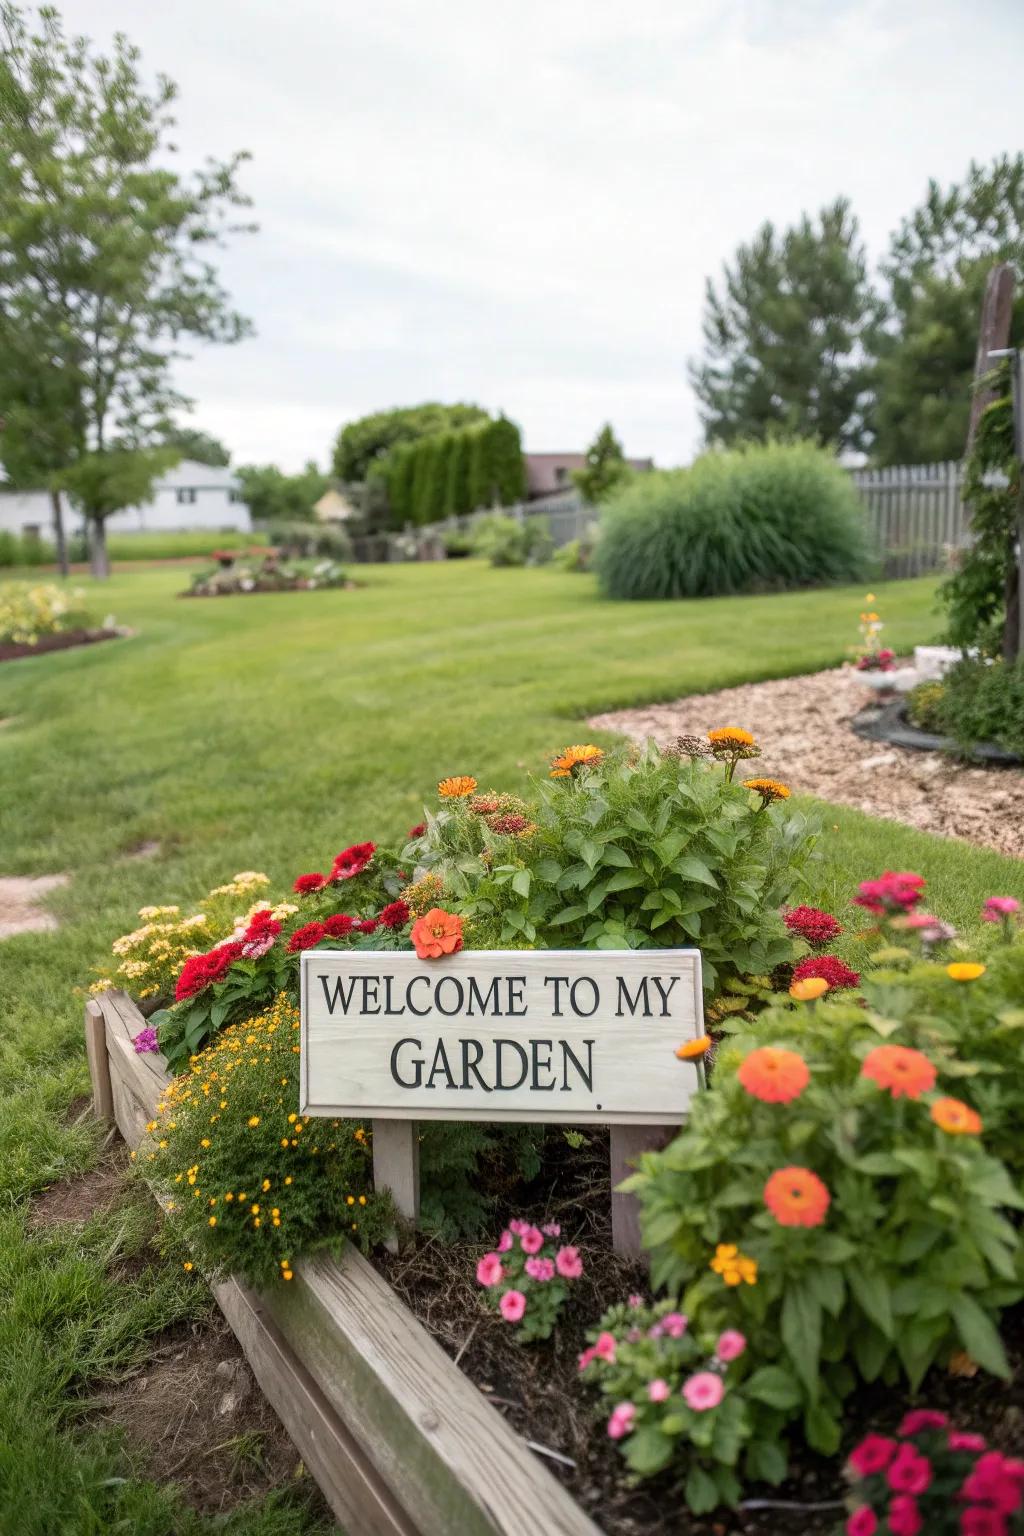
[594,442,867,598]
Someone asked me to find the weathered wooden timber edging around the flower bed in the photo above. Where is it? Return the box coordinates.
[86,991,600,1536]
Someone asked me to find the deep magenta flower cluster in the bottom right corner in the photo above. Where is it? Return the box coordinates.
[846,1409,1024,1536]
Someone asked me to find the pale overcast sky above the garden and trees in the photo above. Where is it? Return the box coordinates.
[58,0,1024,468]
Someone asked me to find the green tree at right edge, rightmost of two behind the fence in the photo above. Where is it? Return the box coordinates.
[872,155,1024,464]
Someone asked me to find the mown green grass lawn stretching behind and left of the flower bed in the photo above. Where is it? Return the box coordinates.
[0,562,1024,1536]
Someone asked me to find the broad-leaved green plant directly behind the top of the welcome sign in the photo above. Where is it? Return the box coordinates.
[418,748,817,991]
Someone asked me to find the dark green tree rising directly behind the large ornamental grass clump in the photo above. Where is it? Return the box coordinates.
[689,198,875,449]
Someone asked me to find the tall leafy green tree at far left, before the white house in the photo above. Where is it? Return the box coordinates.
[0,3,252,573]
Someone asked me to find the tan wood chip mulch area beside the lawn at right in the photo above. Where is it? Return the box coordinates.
[588,667,1024,859]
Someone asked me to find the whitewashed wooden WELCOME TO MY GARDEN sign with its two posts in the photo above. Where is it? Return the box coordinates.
[299,949,703,1253]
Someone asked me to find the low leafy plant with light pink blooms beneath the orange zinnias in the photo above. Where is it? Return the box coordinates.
[583,1301,800,1514]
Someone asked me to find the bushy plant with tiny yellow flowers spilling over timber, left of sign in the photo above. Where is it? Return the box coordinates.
[148,997,390,1286]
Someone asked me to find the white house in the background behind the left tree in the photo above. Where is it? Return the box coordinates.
[0,459,252,539]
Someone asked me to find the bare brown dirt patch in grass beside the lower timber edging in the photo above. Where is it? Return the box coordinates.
[89,1313,330,1519]
